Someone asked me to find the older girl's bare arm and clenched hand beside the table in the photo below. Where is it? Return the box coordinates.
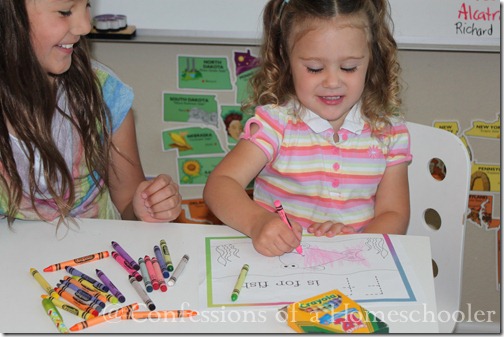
[110,110,181,222]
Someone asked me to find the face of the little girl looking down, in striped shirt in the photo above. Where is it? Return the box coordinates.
[289,16,370,131]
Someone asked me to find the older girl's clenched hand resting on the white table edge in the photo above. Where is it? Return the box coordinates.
[133,174,182,222]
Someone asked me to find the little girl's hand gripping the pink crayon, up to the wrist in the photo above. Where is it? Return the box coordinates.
[250,213,303,256]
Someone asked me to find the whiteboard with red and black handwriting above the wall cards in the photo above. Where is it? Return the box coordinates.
[91,0,500,51]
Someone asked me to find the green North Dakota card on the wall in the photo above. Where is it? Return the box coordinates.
[177,56,233,90]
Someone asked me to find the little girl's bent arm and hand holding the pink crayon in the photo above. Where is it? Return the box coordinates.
[203,140,302,256]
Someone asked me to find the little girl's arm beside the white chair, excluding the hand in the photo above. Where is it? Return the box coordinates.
[364,163,410,234]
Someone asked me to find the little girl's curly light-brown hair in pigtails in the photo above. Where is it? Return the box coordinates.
[242,0,402,133]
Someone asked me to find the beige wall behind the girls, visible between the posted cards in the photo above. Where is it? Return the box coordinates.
[92,41,501,331]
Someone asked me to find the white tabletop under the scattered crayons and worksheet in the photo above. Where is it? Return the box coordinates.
[0,219,438,333]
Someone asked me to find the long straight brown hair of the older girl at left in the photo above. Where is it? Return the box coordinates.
[0,0,111,225]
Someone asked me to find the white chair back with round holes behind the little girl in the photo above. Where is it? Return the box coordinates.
[407,122,471,333]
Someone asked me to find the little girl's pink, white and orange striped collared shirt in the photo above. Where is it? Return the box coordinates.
[241,100,411,231]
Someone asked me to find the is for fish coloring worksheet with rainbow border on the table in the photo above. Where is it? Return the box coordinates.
[200,234,416,308]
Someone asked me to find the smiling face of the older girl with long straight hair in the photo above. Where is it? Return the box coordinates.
[25,0,91,75]
